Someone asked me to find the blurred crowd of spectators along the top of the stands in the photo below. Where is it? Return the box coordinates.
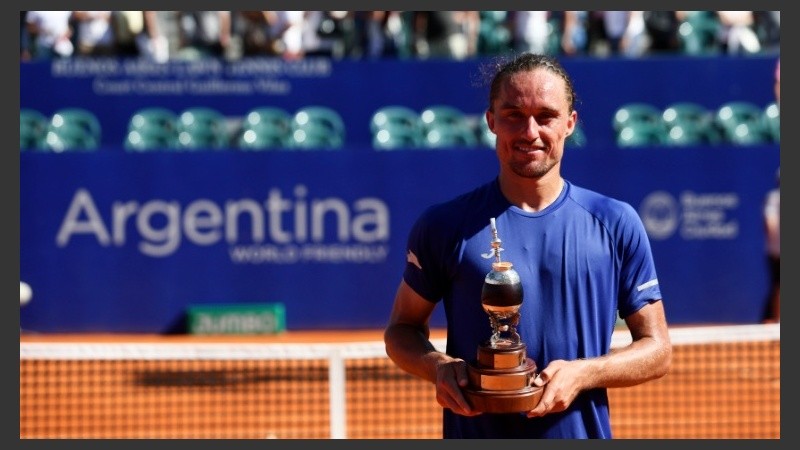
[20,11,780,62]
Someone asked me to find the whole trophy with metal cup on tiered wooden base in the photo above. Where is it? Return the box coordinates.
[464,217,543,413]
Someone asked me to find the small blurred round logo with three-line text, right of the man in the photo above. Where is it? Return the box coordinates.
[639,191,740,240]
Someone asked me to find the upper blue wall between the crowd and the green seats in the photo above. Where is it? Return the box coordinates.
[20,55,776,151]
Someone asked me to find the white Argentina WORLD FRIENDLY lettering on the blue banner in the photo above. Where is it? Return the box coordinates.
[56,185,390,264]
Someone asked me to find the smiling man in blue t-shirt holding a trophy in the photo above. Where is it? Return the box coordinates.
[384,53,672,438]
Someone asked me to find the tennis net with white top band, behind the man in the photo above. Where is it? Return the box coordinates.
[20,324,780,439]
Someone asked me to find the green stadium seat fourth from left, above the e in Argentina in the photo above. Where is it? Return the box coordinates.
[178,107,230,149]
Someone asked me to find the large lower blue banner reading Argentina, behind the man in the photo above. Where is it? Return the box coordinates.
[20,145,780,333]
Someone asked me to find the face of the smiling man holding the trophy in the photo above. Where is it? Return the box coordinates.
[486,68,578,178]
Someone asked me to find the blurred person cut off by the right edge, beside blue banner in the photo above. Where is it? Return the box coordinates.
[762,168,781,323]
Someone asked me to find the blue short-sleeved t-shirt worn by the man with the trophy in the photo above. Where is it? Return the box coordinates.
[403,179,661,438]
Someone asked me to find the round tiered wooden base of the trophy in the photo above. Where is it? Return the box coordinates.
[464,344,543,413]
